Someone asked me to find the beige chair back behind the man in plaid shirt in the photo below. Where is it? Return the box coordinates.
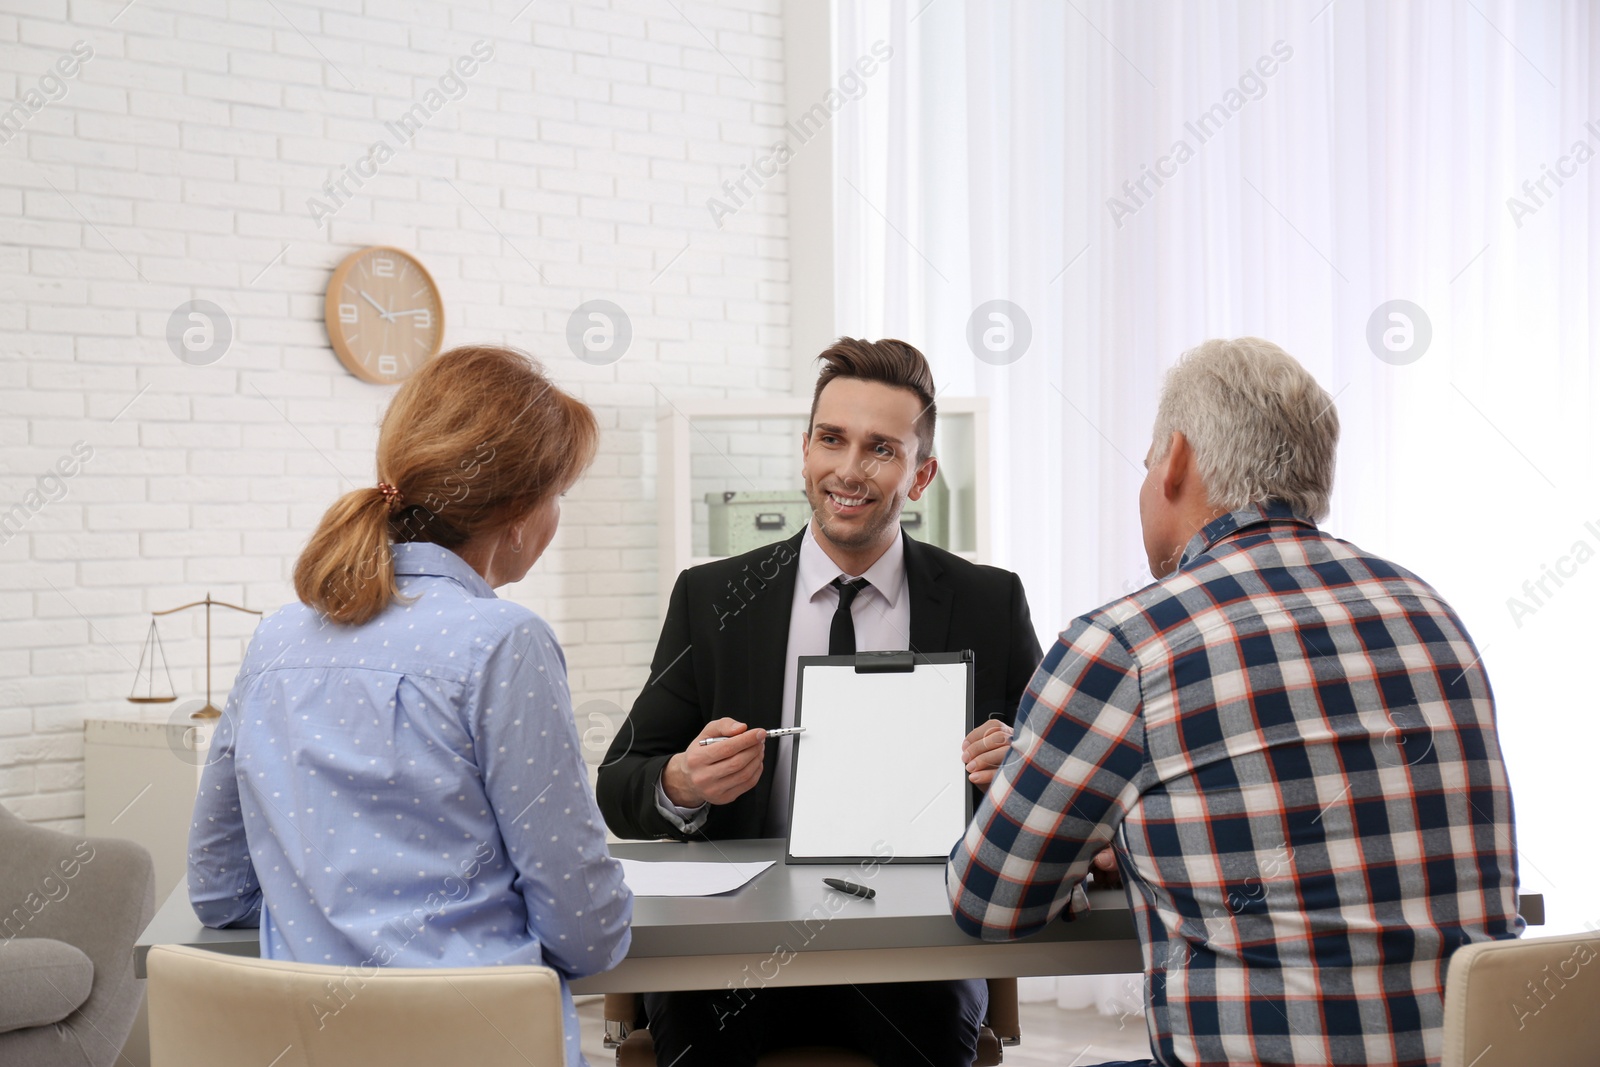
[1440,933,1600,1067]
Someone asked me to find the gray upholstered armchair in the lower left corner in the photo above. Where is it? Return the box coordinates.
[0,805,155,1067]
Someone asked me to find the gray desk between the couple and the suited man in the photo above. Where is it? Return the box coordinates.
[134,840,1142,993]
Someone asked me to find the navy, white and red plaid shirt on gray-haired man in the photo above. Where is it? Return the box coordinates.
[946,504,1523,1067]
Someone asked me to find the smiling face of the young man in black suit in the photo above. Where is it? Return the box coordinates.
[803,378,938,563]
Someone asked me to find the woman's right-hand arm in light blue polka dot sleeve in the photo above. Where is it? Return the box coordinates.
[470,613,634,977]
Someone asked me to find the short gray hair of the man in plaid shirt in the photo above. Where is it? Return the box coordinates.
[1150,338,1339,522]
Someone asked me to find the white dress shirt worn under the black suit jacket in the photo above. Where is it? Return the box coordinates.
[656,525,910,837]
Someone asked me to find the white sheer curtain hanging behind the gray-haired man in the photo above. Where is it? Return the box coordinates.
[835,0,1600,1011]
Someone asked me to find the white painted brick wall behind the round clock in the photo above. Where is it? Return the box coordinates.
[0,0,790,829]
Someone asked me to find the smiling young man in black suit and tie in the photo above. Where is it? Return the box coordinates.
[597,338,1040,1067]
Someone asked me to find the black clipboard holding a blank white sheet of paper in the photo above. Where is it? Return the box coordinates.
[784,649,976,864]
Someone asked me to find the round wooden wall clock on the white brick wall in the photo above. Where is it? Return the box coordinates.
[323,245,445,384]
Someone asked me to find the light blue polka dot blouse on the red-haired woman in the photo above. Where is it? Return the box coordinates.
[189,544,634,1065]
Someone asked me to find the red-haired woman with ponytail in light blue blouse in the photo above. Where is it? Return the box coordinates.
[189,347,632,1064]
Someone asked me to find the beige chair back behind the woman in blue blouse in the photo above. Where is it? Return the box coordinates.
[146,945,566,1067]
